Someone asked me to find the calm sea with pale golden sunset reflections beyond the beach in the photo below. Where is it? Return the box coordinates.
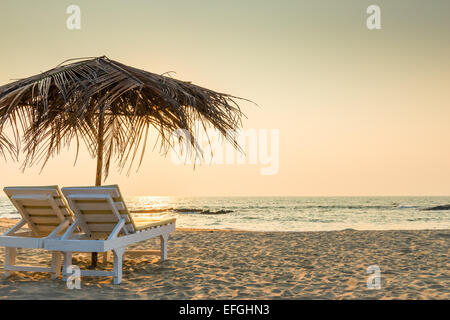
[0,196,450,231]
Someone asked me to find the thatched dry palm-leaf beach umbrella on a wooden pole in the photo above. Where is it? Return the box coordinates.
[0,56,243,266]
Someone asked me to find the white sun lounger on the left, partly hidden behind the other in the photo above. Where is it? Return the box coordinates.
[0,186,73,279]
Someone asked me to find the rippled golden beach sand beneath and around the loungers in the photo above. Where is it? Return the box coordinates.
[0,219,450,299]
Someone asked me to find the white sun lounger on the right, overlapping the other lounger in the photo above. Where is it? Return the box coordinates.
[45,185,175,284]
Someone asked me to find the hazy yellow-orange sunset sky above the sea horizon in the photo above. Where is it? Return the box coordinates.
[0,0,450,196]
